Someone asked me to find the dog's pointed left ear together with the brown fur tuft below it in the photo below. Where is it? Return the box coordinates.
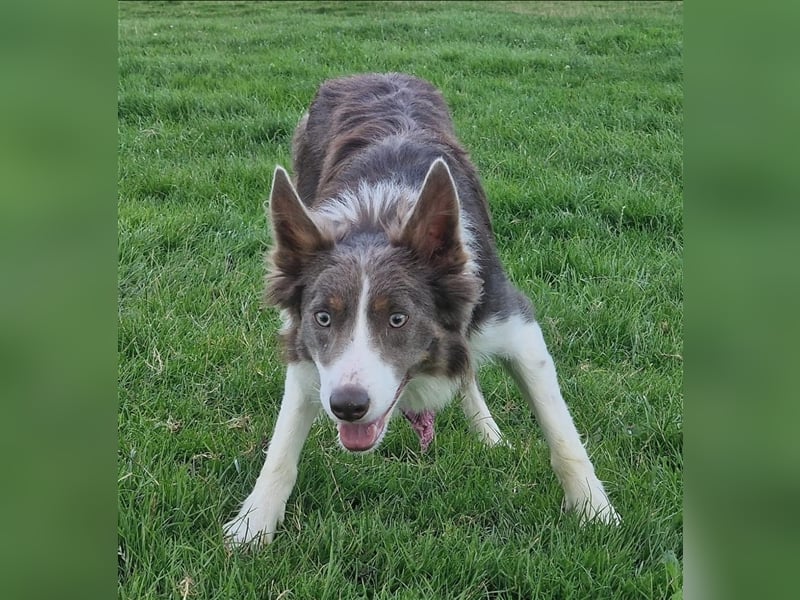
[265,167,333,308]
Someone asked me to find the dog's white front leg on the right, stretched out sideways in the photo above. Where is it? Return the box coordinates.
[507,318,619,523]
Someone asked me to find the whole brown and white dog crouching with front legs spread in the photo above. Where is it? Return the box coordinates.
[225,73,619,545]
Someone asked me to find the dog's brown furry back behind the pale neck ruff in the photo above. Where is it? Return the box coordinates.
[294,74,468,200]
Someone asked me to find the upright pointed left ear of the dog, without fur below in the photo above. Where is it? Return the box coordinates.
[269,166,329,257]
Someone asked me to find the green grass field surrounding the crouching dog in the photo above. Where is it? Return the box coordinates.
[118,2,683,600]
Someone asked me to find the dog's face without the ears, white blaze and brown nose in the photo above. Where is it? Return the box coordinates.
[299,246,438,451]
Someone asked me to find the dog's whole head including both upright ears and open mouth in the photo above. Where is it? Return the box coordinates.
[267,160,479,452]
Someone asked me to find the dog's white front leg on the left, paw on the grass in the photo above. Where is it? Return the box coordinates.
[225,363,320,545]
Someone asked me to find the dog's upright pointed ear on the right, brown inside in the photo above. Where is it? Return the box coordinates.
[400,158,463,262]
